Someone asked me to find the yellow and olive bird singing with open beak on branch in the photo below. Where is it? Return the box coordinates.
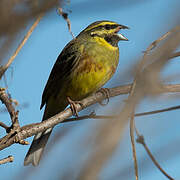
[24,20,129,166]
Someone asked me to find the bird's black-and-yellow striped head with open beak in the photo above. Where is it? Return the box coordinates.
[78,21,129,46]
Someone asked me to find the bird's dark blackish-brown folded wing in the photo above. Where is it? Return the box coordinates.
[40,40,80,109]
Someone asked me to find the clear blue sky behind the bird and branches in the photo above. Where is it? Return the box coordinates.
[0,0,180,180]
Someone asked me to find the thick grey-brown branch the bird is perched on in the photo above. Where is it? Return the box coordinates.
[0,84,180,150]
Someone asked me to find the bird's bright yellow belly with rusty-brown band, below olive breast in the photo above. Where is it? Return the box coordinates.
[66,56,117,100]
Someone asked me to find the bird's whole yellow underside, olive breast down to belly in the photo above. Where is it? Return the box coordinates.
[66,42,119,100]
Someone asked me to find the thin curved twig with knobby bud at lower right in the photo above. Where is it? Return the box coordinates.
[135,128,174,180]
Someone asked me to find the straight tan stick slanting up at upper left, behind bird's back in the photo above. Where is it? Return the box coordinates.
[0,14,43,79]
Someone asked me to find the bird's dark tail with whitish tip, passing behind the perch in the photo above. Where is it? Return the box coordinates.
[24,98,66,166]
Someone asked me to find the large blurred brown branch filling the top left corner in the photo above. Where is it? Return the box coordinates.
[0,0,60,64]
